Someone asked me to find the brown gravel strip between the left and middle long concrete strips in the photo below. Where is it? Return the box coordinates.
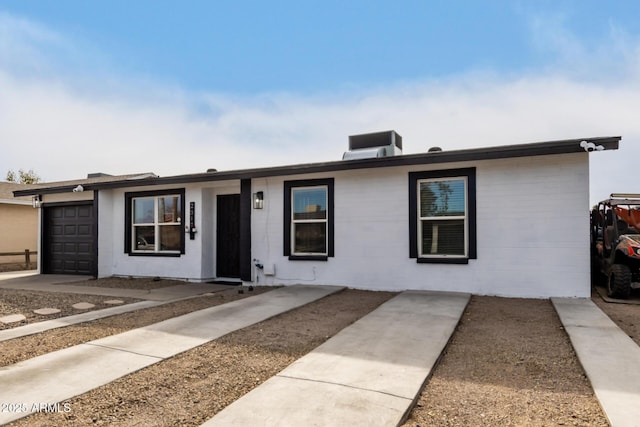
[0,284,394,426]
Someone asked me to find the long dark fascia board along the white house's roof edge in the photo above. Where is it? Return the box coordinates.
[13,136,622,197]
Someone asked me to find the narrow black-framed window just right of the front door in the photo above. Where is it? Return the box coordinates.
[284,178,334,260]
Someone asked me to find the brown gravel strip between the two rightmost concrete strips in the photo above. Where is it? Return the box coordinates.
[404,297,608,427]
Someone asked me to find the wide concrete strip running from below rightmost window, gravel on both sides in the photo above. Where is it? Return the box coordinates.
[203,291,470,427]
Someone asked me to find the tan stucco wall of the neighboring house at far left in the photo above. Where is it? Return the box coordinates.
[0,203,38,264]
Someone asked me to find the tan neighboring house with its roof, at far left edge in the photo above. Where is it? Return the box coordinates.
[0,182,38,265]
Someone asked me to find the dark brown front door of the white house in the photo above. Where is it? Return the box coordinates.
[216,194,240,278]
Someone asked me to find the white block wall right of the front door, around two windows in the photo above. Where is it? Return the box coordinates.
[252,153,590,297]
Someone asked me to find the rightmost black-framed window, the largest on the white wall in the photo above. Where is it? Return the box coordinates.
[409,168,477,264]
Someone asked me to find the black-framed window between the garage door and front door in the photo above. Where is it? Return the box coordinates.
[125,189,185,256]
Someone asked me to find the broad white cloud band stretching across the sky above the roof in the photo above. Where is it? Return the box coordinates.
[0,10,640,206]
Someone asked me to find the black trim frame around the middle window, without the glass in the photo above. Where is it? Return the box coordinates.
[282,178,335,261]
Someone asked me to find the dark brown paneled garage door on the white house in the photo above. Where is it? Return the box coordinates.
[42,202,97,276]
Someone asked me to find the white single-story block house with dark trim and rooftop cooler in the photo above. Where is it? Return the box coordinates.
[16,131,621,297]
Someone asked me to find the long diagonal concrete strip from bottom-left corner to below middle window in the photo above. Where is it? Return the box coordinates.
[0,286,343,424]
